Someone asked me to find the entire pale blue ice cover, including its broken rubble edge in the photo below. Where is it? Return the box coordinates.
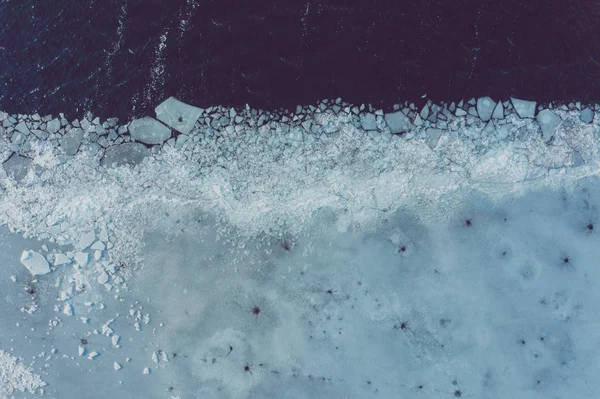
[0,98,600,399]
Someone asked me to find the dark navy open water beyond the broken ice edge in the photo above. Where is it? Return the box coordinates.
[0,0,600,119]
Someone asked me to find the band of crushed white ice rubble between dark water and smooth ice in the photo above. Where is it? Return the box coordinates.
[0,97,600,268]
